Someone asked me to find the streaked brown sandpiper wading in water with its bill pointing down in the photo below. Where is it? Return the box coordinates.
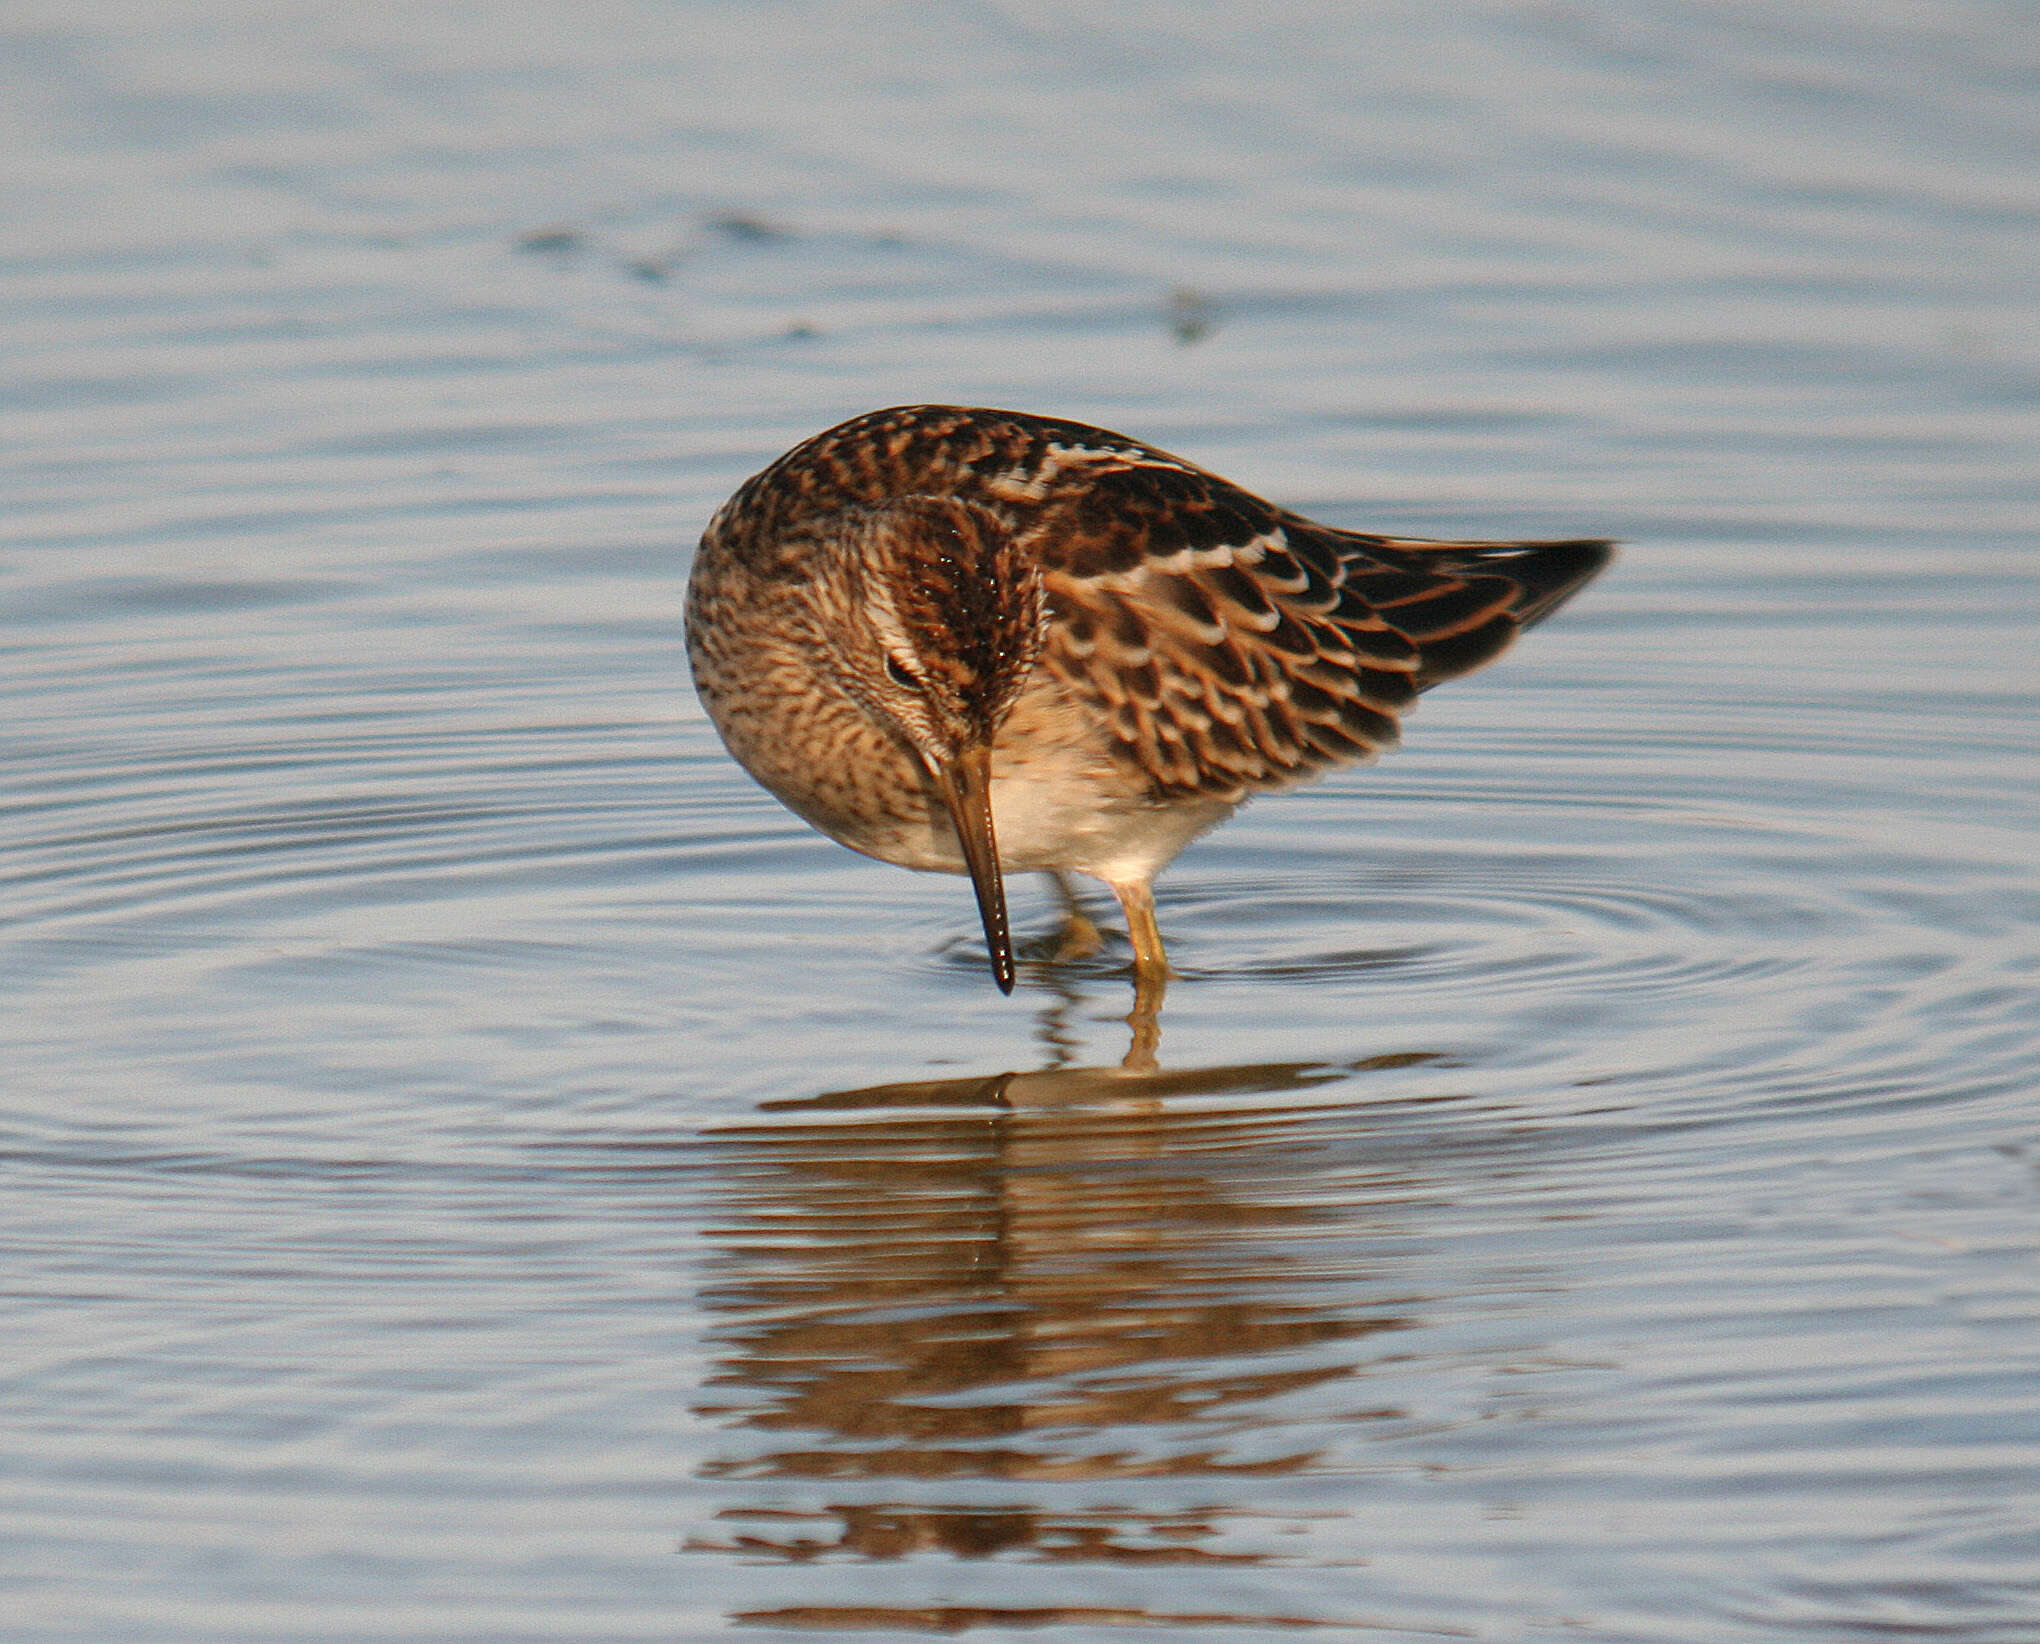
[687,406,1612,991]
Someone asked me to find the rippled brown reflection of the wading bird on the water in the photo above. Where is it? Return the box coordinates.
[687,1020,1438,1630]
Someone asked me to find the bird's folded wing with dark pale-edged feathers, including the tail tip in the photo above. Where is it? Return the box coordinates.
[958,418,1608,798]
